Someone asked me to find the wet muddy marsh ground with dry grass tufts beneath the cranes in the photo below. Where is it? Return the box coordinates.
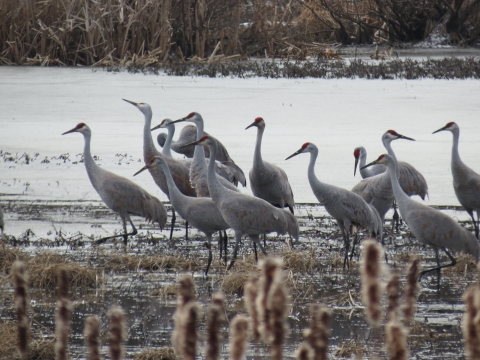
[0,200,477,359]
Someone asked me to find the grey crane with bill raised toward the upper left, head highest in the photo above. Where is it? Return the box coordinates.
[123,99,197,240]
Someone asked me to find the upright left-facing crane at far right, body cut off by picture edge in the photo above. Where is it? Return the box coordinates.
[433,122,480,238]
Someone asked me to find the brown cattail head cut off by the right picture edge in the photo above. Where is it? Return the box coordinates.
[462,285,480,359]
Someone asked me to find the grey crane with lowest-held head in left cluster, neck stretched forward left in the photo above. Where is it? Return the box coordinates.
[134,156,229,275]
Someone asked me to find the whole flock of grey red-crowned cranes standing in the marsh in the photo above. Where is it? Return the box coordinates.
[60,99,480,282]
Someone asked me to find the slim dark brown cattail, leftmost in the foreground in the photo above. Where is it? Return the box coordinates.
[12,261,29,359]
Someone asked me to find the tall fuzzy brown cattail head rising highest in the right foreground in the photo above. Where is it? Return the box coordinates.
[361,240,383,327]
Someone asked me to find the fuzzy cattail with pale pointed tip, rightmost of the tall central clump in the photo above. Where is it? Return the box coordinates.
[267,270,288,360]
